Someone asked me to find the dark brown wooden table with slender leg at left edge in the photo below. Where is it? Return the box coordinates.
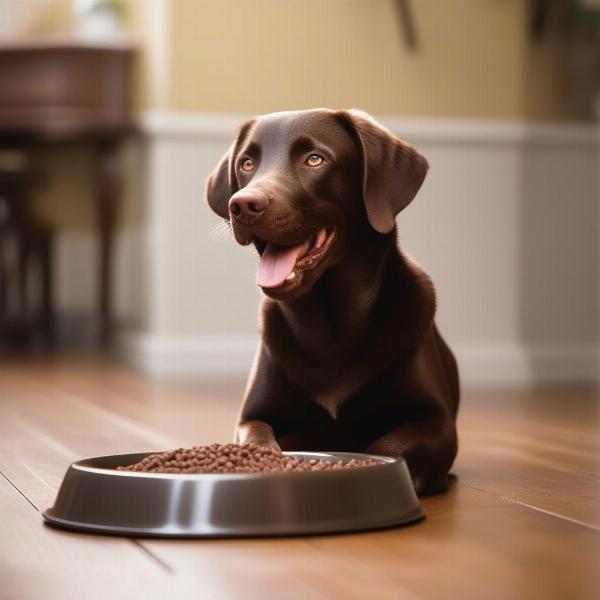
[0,38,134,342]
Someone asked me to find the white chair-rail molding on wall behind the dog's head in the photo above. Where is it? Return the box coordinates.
[139,110,600,148]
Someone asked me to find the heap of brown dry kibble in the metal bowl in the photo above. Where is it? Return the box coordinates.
[117,444,377,473]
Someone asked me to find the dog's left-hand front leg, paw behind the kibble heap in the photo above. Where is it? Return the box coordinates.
[235,342,296,450]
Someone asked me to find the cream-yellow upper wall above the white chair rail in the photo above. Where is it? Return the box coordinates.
[143,0,578,119]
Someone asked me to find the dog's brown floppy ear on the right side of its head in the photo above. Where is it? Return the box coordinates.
[335,109,429,233]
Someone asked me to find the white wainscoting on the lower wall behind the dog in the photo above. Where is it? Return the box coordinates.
[113,112,600,386]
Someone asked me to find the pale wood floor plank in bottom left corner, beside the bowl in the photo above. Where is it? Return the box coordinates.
[0,468,173,600]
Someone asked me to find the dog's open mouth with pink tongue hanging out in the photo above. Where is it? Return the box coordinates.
[256,227,335,288]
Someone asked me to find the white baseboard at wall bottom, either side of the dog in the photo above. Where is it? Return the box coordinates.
[121,334,600,387]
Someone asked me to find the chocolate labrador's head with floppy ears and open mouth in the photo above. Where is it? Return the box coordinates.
[206,109,428,299]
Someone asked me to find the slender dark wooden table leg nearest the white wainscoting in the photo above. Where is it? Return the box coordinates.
[96,142,121,345]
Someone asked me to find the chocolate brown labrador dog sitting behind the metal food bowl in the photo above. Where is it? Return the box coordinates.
[206,109,459,494]
